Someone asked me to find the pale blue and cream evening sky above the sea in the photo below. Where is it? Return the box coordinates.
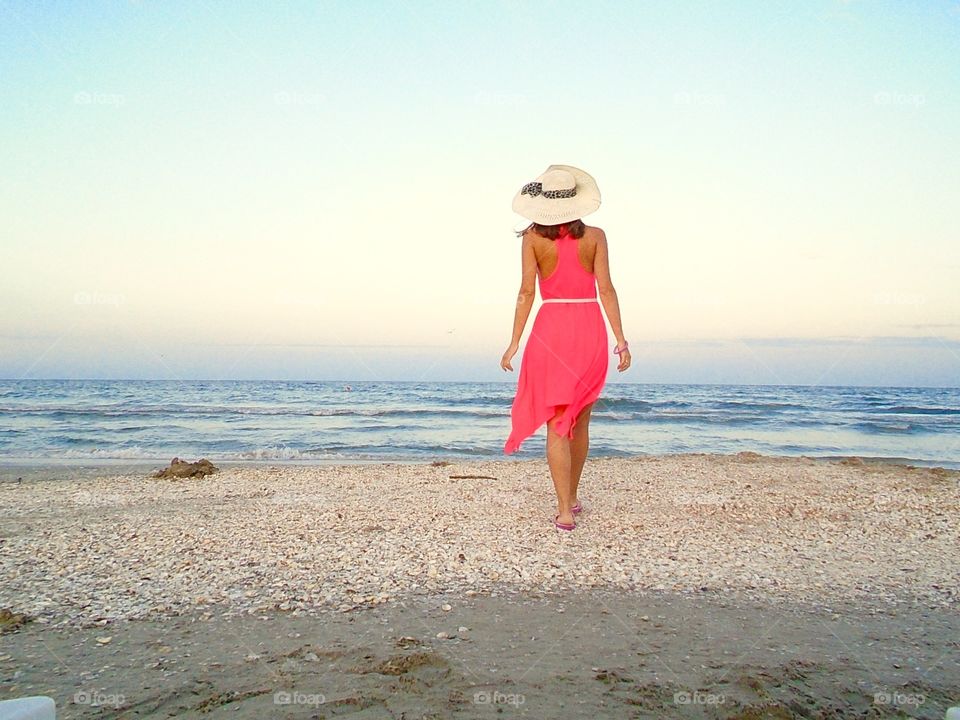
[0,0,960,387]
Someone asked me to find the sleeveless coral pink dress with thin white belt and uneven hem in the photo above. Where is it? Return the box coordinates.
[503,227,609,455]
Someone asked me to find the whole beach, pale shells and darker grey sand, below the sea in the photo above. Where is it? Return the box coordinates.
[0,453,960,718]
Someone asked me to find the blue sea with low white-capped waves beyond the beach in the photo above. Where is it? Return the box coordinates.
[0,379,960,469]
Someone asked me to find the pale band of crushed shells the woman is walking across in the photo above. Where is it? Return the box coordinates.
[0,453,960,625]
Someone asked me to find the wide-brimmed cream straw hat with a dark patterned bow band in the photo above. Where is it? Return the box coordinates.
[513,165,600,225]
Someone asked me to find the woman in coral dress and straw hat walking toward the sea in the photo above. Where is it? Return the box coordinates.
[500,165,630,530]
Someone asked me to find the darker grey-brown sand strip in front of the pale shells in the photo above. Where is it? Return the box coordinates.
[0,590,960,720]
